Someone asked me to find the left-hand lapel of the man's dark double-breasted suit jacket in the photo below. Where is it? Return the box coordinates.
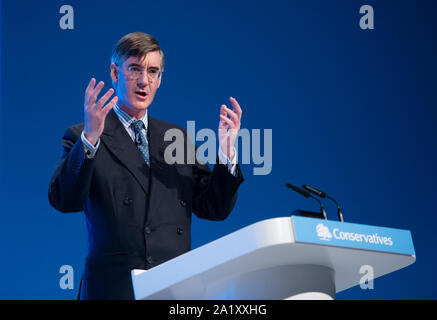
[101,110,151,194]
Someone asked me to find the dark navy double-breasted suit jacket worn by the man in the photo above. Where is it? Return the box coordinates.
[49,110,243,299]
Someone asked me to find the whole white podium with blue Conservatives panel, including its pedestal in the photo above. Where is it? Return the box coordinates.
[131,216,416,300]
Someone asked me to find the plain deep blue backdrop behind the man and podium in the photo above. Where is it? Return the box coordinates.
[0,0,437,299]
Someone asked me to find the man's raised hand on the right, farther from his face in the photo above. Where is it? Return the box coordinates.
[219,97,243,160]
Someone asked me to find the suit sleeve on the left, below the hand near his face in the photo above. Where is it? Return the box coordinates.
[49,127,95,212]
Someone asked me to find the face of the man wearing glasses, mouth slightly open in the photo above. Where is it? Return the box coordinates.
[111,51,162,119]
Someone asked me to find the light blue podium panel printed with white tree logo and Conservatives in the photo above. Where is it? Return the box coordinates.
[291,216,415,255]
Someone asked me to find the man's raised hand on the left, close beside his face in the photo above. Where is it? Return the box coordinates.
[83,78,118,146]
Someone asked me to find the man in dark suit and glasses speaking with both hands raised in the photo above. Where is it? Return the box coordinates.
[49,32,243,299]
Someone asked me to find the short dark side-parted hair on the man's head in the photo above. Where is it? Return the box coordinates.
[111,32,165,71]
